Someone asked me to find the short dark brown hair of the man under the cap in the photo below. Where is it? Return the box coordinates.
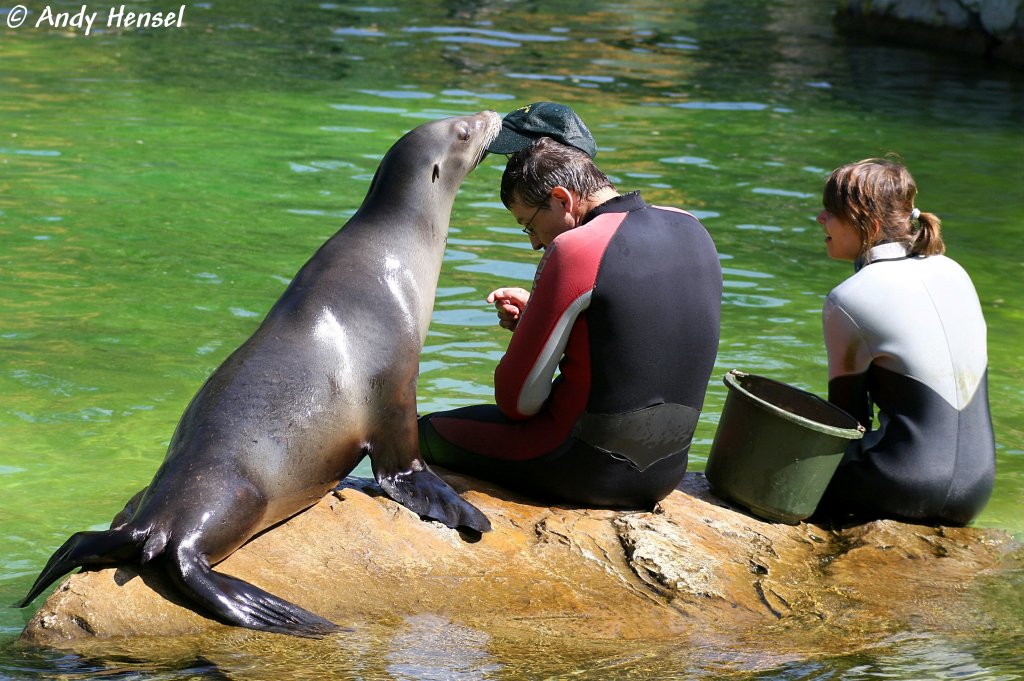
[502,137,614,208]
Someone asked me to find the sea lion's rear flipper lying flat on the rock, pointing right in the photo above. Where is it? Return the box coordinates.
[165,547,345,638]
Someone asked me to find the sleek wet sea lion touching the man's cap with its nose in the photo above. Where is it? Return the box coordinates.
[16,112,501,637]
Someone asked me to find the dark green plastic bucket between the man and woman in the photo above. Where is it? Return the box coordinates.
[705,371,864,524]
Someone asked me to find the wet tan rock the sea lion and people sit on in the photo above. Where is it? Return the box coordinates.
[22,471,1019,654]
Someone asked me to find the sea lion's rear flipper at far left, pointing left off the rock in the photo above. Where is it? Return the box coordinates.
[14,527,145,607]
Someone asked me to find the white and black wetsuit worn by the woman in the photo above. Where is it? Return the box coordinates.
[822,243,995,524]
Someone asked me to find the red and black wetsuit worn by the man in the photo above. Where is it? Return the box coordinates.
[420,193,722,507]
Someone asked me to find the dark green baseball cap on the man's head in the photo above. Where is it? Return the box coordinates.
[487,101,597,158]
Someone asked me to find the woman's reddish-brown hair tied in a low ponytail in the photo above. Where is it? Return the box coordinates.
[821,159,946,258]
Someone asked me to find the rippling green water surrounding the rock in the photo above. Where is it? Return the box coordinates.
[0,0,1024,679]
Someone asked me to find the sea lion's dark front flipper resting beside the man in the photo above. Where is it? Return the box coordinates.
[374,468,490,533]
